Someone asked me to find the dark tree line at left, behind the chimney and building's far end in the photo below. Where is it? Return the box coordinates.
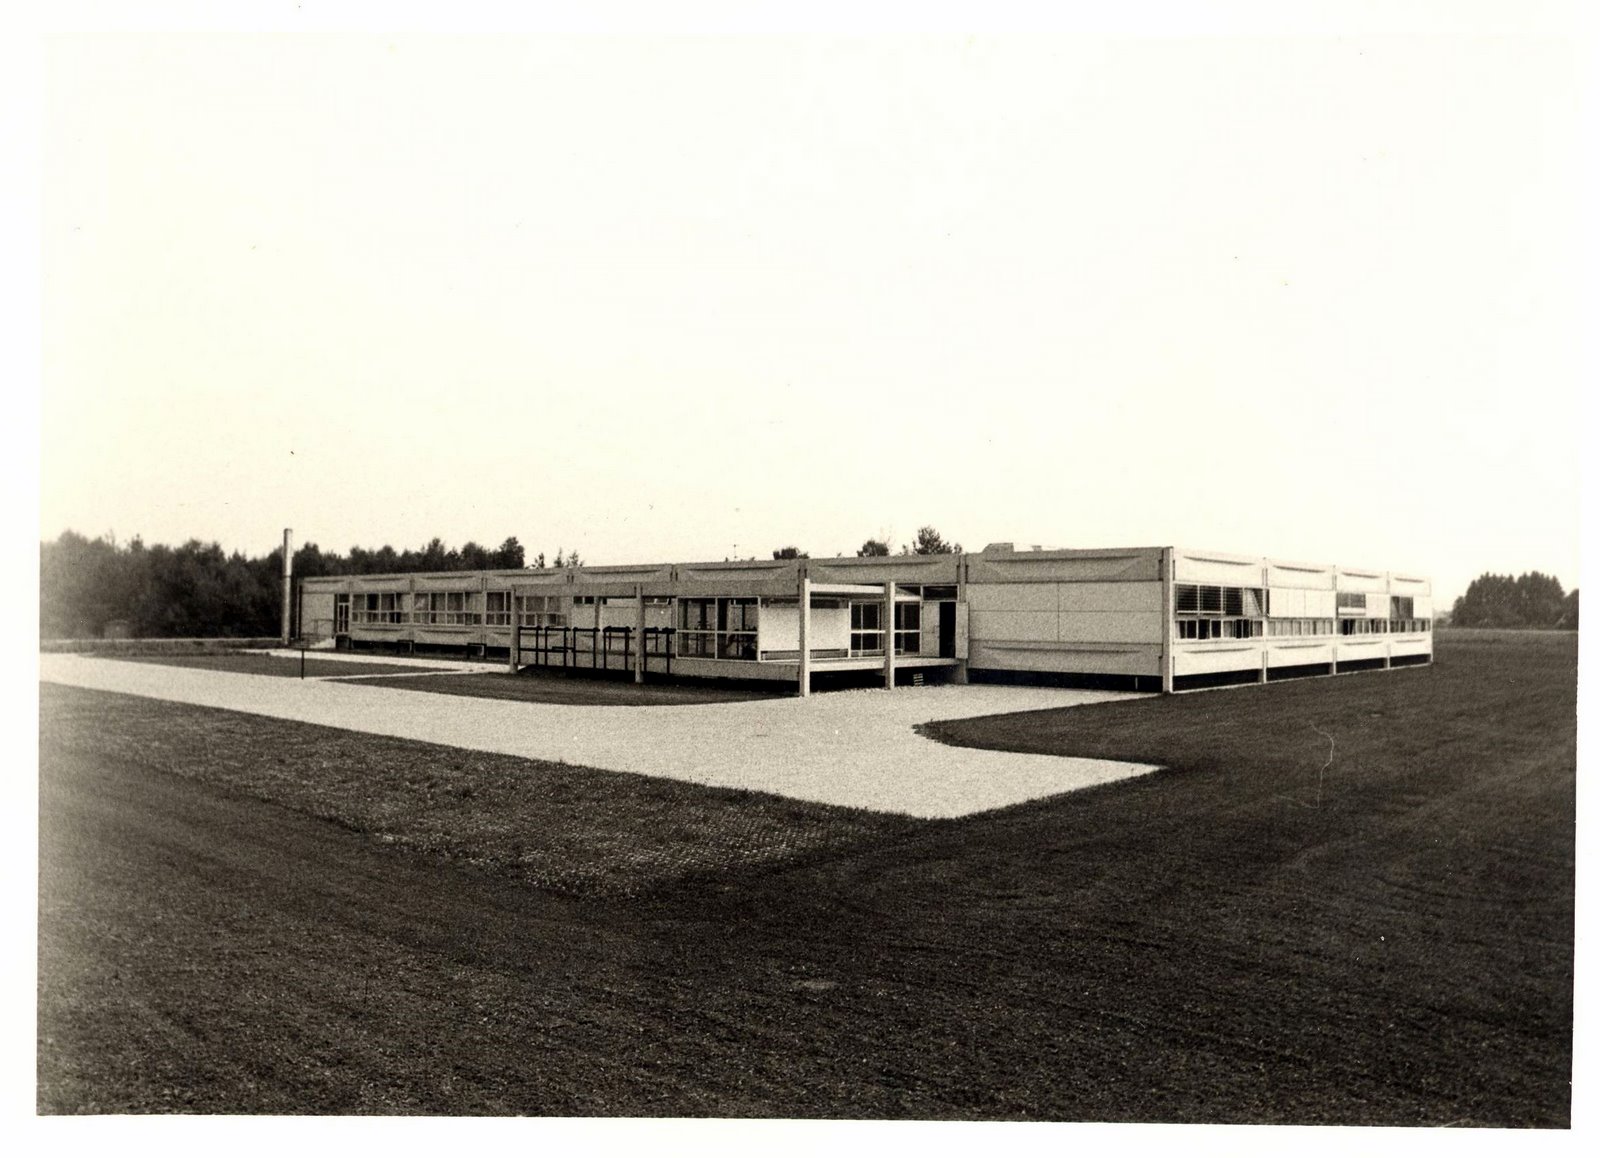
[38,531,582,640]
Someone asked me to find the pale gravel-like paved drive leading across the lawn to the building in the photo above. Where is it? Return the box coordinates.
[38,654,1155,819]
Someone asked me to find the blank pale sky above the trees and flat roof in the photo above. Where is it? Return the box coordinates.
[31,6,1584,600]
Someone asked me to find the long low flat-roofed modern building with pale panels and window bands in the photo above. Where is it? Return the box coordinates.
[296,544,1434,694]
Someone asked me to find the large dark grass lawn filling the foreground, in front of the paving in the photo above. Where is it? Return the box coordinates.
[38,632,1576,1126]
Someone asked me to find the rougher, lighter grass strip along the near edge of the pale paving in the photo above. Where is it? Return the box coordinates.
[42,684,914,896]
